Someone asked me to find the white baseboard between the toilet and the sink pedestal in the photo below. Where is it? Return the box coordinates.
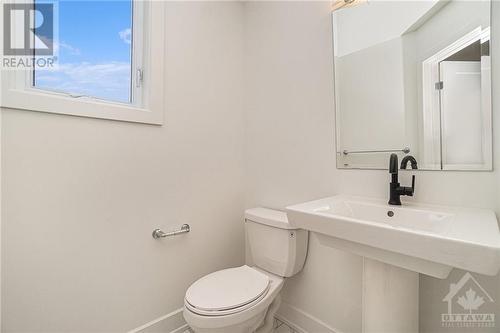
[276,302,342,333]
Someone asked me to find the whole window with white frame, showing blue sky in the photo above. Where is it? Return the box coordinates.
[2,0,165,124]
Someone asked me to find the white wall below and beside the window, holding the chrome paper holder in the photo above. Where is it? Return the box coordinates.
[1,2,244,332]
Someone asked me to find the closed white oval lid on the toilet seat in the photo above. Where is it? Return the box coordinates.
[186,265,270,311]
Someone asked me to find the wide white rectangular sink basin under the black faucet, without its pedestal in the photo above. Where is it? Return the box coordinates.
[287,195,500,278]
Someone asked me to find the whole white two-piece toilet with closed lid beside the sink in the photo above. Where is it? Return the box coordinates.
[183,208,308,333]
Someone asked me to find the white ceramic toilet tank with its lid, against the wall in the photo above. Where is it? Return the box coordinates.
[245,208,309,277]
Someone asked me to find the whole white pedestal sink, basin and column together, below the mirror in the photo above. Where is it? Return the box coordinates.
[287,195,500,333]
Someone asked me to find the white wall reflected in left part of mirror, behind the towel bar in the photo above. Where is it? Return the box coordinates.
[335,38,410,168]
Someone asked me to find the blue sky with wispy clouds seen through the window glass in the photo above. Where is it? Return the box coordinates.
[34,0,132,103]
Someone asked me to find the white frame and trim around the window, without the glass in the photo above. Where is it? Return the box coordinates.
[0,0,166,125]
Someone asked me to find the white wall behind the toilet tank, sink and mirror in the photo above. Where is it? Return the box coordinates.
[246,2,500,332]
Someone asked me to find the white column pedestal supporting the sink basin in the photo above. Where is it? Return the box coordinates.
[362,258,418,333]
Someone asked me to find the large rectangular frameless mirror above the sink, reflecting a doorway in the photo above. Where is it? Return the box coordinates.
[332,0,492,170]
